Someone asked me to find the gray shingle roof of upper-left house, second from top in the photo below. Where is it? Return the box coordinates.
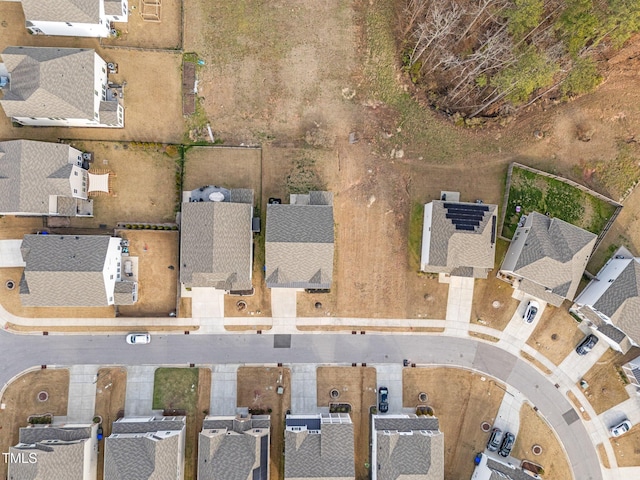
[0,47,95,120]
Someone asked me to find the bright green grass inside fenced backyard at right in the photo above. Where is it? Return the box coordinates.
[502,167,616,238]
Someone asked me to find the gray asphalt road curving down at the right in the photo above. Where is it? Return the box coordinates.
[0,331,602,480]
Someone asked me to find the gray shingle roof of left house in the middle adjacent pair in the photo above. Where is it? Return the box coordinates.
[180,202,253,290]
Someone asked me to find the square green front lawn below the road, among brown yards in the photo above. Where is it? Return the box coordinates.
[152,368,199,415]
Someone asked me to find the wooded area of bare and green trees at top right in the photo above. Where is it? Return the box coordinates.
[401,0,640,118]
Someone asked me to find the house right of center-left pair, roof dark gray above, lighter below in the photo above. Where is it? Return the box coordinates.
[265,192,334,290]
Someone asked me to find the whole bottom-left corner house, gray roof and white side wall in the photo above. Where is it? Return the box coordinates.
[7,423,98,480]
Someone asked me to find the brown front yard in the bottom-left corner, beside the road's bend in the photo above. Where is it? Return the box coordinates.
[0,369,69,478]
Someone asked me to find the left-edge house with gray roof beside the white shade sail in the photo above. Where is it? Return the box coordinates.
[0,140,93,217]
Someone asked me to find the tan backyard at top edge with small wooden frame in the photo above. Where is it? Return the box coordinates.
[102,0,182,49]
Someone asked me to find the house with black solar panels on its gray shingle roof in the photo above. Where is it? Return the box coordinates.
[420,200,498,278]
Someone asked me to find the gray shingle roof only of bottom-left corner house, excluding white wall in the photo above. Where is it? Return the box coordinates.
[8,426,92,480]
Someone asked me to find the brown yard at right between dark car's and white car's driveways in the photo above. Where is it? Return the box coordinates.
[583,348,629,414]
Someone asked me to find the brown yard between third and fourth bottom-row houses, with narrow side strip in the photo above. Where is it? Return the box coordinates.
[238,367,291,480]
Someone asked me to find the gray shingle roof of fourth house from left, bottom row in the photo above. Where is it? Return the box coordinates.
[284,423,355,480]
